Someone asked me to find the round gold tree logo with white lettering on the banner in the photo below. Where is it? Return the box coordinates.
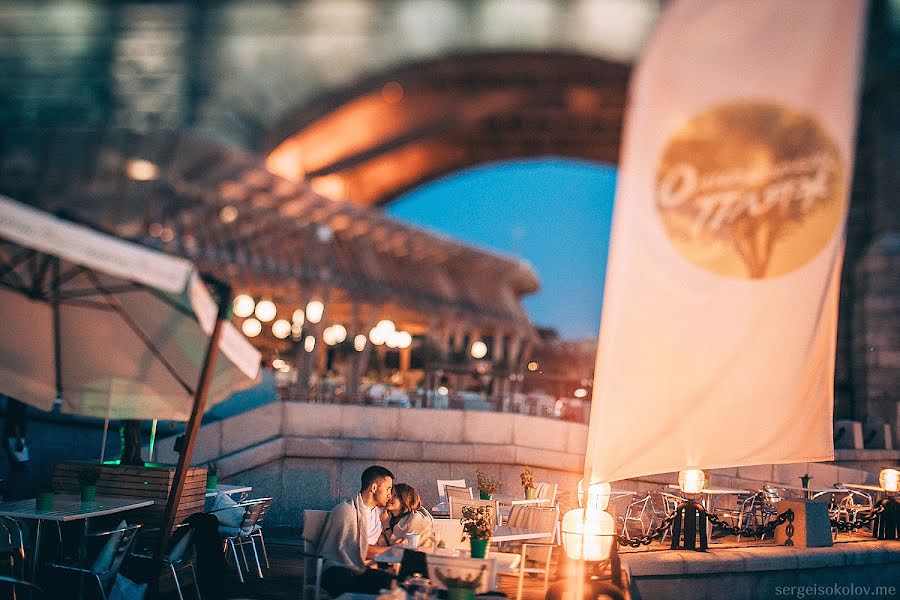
[655,102,846,279]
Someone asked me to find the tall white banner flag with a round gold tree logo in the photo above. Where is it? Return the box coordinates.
[585,0,866,481]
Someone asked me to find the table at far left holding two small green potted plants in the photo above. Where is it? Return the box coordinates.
[0,494,153,580]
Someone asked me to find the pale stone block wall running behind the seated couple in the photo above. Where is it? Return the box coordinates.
[157,402,882,529]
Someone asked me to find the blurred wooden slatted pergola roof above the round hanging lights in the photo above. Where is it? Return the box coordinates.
[0,129,538,346]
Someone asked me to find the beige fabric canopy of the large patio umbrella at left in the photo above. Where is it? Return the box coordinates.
[0,196,260,421]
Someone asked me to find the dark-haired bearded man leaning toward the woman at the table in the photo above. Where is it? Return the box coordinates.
[318,465,394,598]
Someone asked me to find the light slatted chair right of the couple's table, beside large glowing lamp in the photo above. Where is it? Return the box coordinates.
[491,504,559,600]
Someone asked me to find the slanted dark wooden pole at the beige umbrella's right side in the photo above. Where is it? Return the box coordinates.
[149,278,231,598]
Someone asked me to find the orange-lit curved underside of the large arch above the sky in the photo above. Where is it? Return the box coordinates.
[260,52,630,206]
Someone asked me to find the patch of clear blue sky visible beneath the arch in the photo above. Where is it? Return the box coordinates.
[386,158,616,339]
